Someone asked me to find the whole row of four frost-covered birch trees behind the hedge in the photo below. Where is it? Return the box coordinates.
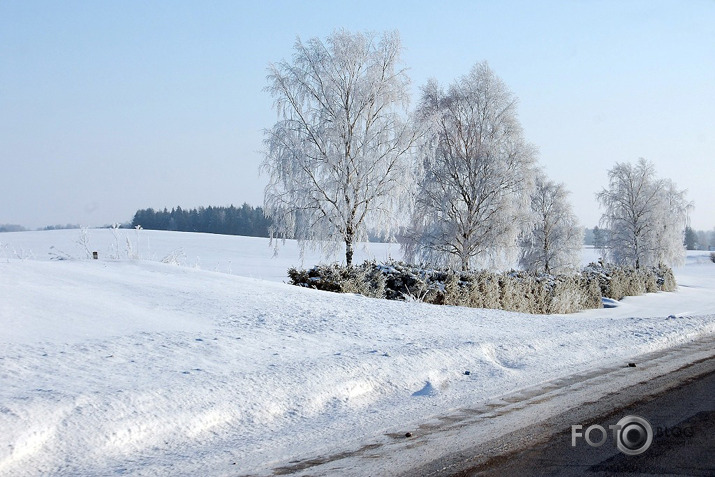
[262,31,689,273]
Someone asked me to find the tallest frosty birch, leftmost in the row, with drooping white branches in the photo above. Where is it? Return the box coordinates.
[262,31,416,266]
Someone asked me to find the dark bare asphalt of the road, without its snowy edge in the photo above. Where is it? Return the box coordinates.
[456,358,715,477]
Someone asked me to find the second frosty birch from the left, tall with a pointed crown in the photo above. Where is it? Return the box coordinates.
[401,63,536,270]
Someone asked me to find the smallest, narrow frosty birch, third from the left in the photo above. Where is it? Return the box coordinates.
[520,175,583,273]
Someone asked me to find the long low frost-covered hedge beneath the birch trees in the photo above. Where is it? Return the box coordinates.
[288,262,676,314]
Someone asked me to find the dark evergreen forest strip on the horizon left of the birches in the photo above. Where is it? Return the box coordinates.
[132,204,271,237]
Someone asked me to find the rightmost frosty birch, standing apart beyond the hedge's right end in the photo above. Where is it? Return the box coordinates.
[596,158,692,268]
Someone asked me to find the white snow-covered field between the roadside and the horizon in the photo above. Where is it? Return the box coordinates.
[0,230,715,476]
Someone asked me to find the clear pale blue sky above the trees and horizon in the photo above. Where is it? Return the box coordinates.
[0,0,715,229]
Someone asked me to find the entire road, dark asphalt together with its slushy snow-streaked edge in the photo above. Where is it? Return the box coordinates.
[274,336,715,477]
